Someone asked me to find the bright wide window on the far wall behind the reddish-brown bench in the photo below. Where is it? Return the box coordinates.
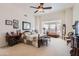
[43,22,61,34]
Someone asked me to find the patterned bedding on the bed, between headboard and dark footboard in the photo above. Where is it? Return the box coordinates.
[22,32,38,47]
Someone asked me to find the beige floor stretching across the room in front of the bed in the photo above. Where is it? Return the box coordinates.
[0,38,71,56]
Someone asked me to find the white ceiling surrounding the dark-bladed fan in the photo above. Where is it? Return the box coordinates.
[0,3,74,14]
